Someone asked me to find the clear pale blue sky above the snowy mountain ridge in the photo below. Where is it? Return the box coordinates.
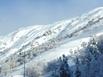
[0,0,103,35]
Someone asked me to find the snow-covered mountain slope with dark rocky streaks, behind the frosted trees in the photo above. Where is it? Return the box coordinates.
[0,7,103,75]
